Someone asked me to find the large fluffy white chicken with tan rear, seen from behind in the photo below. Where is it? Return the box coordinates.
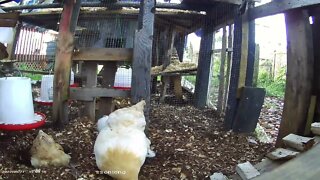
[94,101,155,180]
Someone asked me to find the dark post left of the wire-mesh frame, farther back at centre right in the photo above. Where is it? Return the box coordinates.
[194,15,214,108]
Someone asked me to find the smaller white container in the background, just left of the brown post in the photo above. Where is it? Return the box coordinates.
[40,75,54,102]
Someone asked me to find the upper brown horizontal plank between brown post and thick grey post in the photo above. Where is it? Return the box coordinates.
[73,48,133,61]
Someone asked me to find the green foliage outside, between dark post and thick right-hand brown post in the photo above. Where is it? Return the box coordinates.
[258,67,286,98]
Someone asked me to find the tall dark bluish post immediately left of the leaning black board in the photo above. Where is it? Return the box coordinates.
[224,15,242,130]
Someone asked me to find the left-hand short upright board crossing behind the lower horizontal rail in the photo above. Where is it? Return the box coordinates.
[82,62,98,121]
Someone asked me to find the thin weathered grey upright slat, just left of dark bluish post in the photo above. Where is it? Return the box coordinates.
[217,26,227,114]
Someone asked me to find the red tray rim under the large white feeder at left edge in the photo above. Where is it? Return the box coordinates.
[0,112,47,131]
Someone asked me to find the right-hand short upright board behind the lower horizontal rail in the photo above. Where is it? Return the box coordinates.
[97,62,117,119]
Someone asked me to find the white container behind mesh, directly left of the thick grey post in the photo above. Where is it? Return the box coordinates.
[114,68,132,88]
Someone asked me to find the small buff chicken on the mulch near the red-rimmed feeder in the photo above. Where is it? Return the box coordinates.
[30,130,71,167]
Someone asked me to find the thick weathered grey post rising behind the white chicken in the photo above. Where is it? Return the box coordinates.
[131,0,155,122]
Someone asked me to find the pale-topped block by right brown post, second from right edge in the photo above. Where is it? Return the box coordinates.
[282,134,314,151]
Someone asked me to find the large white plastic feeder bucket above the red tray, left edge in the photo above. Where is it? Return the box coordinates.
[0,77,35,124]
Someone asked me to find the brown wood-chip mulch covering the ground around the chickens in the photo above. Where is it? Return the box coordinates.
[0,101,273,180]
